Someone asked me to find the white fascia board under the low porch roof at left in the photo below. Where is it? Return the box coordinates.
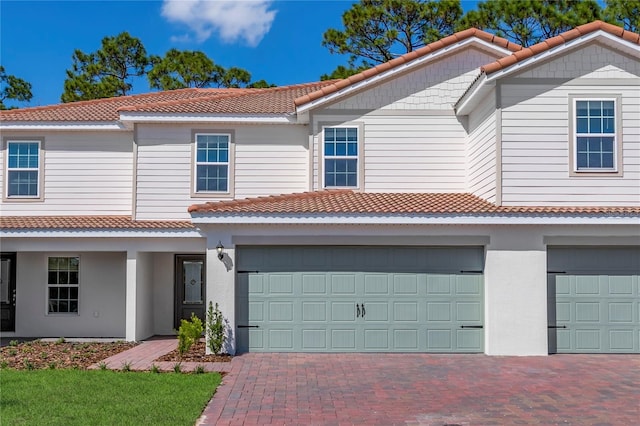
[0,229,205,238]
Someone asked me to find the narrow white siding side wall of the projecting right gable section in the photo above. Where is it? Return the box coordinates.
[467,90,497,202]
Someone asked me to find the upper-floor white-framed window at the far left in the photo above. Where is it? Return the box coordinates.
[5,140,42,198]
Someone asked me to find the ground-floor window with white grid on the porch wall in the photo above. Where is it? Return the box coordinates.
[47,256,80,314]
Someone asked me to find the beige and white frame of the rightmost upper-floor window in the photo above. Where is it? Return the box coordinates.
[569,94,622,177]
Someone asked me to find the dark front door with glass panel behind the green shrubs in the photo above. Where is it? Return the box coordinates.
[174,255,206,330]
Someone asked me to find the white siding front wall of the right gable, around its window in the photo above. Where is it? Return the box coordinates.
[501,45,640,206]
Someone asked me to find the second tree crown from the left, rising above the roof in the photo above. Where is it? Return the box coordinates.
[61,32,151,102]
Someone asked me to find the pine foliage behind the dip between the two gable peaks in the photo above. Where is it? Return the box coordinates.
[459,0,601,47]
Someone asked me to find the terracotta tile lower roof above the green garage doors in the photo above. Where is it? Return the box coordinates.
[189,190,640,215]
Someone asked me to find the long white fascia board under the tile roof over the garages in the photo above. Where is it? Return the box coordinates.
[191,214,640,225]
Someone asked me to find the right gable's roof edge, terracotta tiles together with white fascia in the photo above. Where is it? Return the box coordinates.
[455,21,640,115]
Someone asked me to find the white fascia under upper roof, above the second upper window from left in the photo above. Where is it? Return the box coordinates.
[120,112,298,124]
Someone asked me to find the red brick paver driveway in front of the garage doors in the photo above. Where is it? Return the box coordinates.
[201,354,640,425]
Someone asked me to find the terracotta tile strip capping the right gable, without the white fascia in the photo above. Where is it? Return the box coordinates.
[481,21,640,74]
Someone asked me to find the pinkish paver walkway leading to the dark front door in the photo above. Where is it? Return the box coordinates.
[89,337,231,372]
